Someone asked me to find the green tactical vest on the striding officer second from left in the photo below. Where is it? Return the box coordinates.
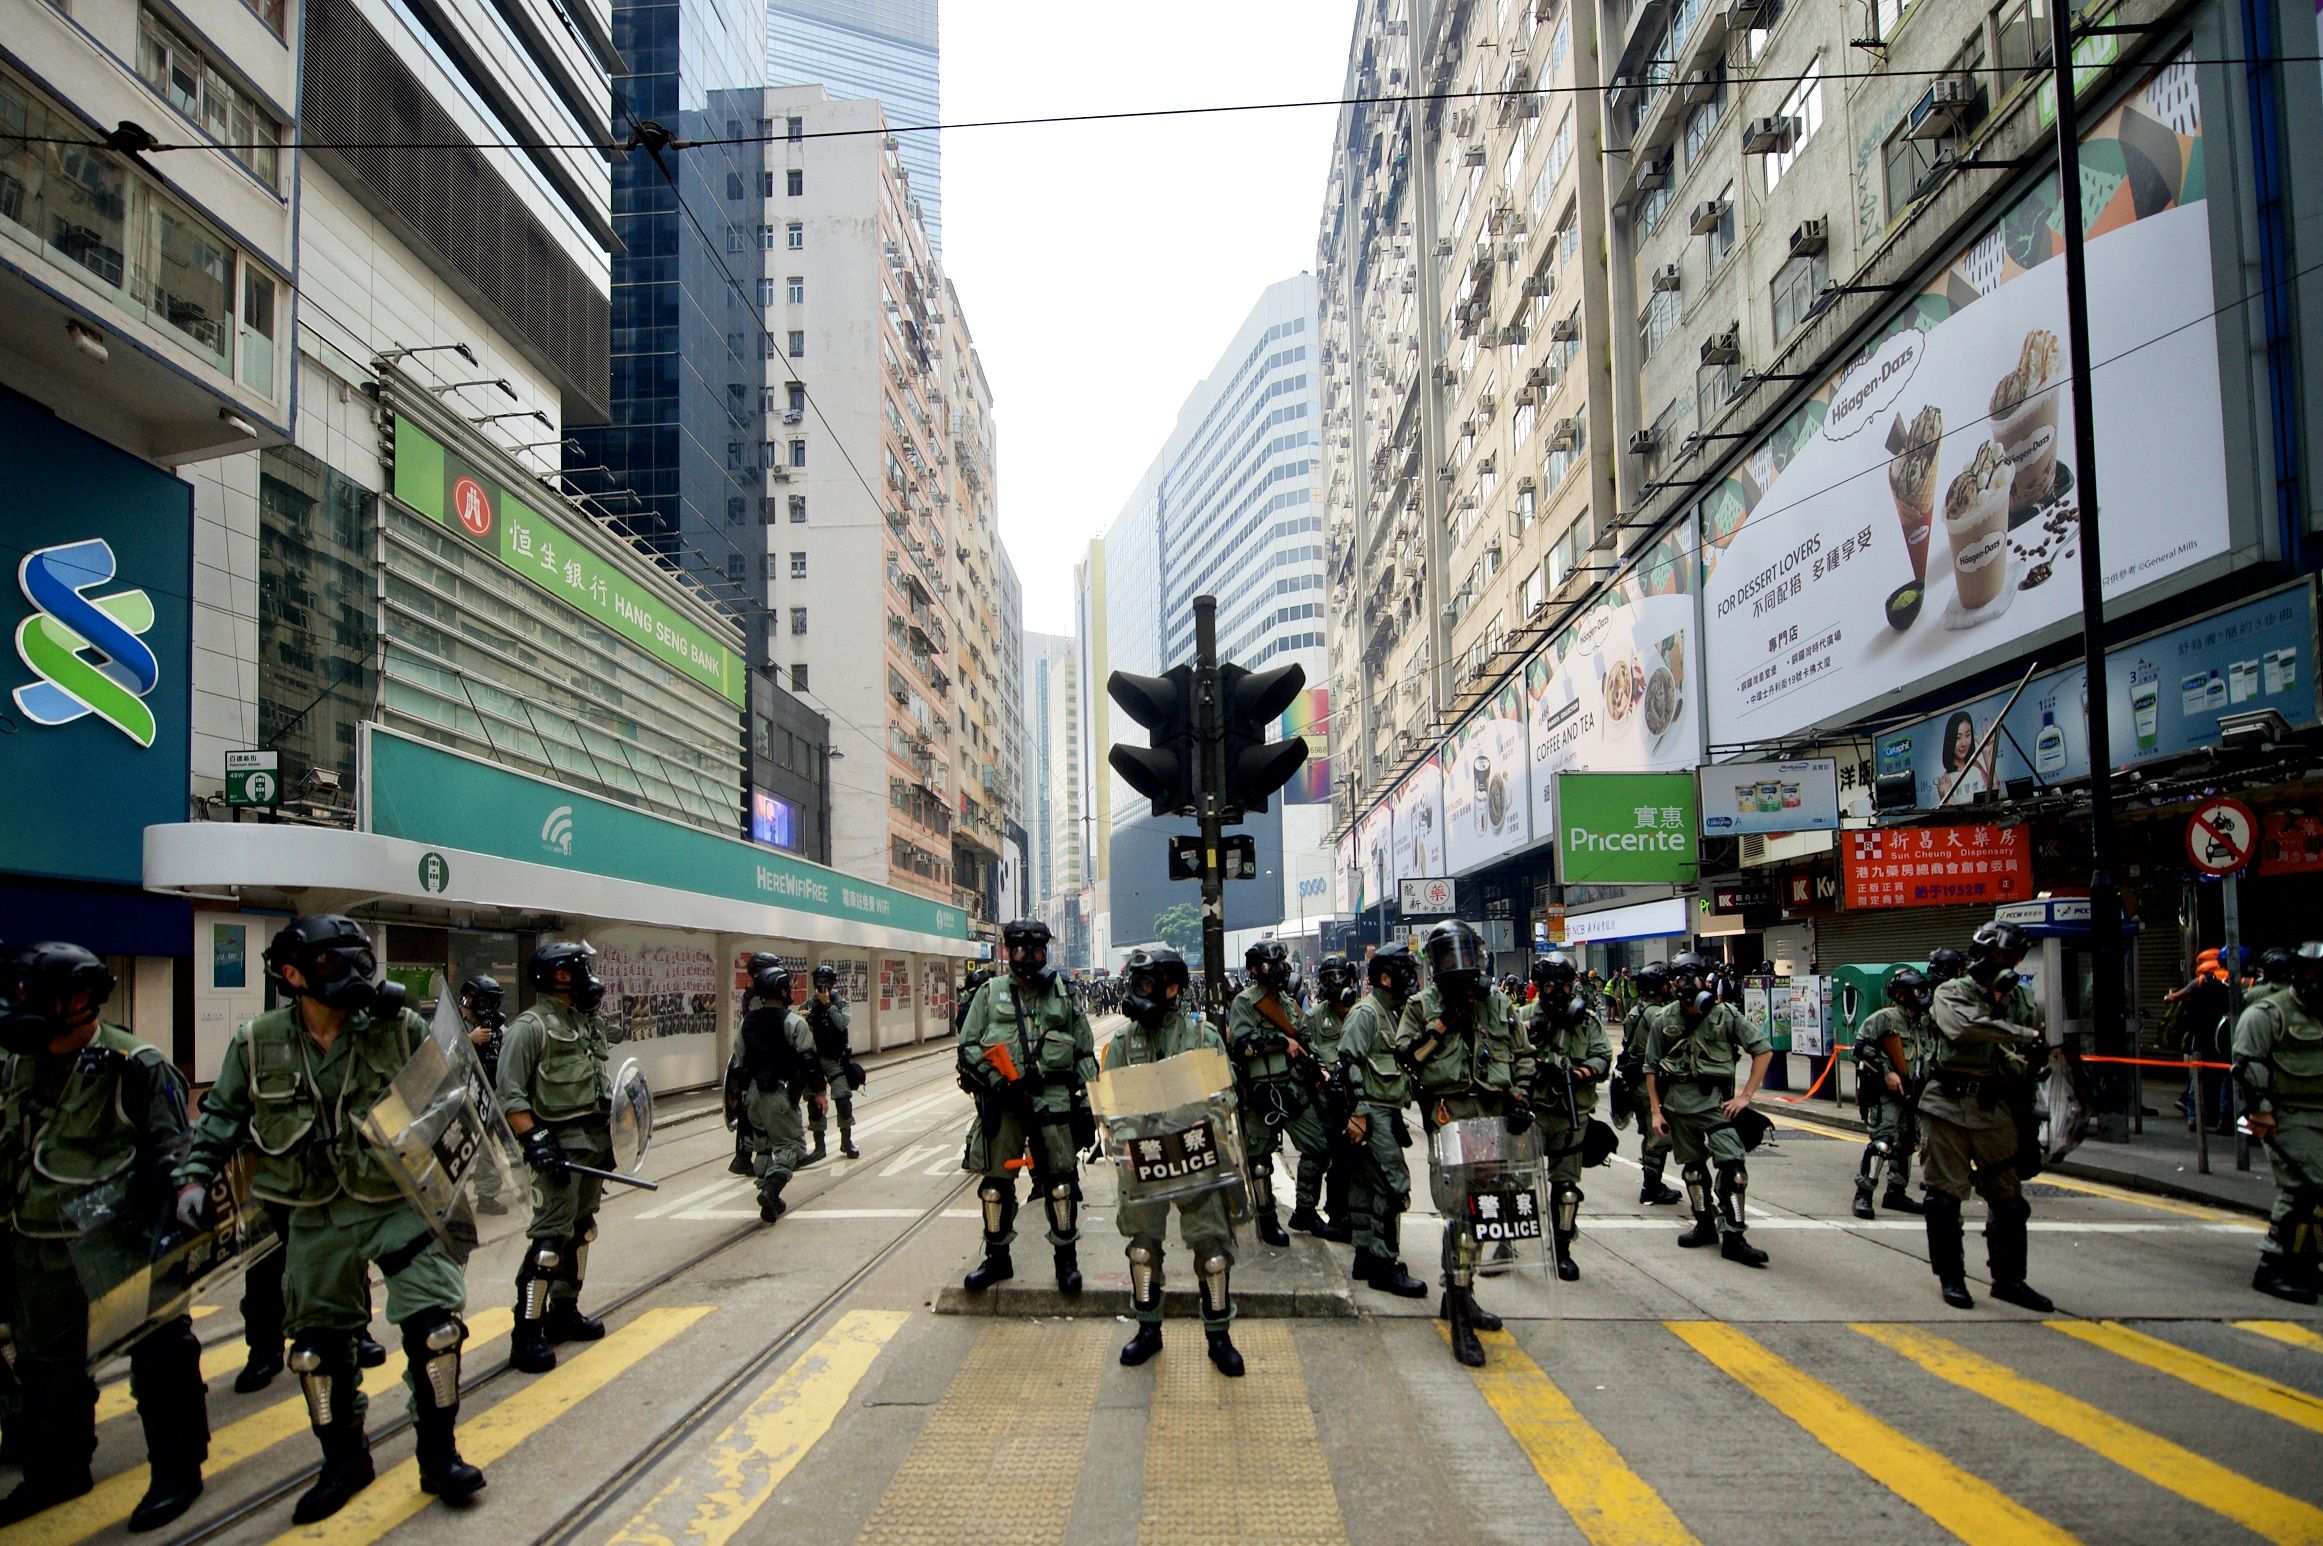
[244,1000,427,1207]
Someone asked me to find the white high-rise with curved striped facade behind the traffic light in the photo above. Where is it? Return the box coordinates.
[1083,274,1331,954]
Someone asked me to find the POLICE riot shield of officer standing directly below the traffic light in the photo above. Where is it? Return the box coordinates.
[1089,1047,1250,1223]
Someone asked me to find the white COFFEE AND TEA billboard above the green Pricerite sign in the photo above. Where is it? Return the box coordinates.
[1524,532,1703,838]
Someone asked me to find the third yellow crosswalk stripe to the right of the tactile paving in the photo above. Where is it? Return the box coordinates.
[1854,1323,2323,1541]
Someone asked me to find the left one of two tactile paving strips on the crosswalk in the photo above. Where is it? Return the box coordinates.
[855,1321,1115,1546]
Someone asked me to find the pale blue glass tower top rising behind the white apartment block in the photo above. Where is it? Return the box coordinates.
[767,0,943,258]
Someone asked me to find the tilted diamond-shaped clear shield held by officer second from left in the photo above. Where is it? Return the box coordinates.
[362,974,527,1260]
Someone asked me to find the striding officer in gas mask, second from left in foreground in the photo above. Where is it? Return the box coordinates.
[177,912,483,1525]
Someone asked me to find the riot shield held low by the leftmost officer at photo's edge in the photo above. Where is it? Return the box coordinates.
[65,1154,281,1367]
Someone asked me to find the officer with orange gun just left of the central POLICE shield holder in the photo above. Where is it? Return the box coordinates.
[959,919,1096,1293]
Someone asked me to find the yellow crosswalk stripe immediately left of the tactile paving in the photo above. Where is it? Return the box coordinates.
[609,1309,911,1546]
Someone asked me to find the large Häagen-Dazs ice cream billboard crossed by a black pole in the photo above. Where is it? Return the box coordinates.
[1700,58,2228,752]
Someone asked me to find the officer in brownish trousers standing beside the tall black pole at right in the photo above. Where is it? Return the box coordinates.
[1919,922,2056,1312]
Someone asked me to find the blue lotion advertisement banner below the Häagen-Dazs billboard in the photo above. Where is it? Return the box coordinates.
[1877,583,2318,810]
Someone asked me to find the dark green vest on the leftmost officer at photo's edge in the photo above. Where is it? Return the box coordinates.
[0,1026,177,1240]
